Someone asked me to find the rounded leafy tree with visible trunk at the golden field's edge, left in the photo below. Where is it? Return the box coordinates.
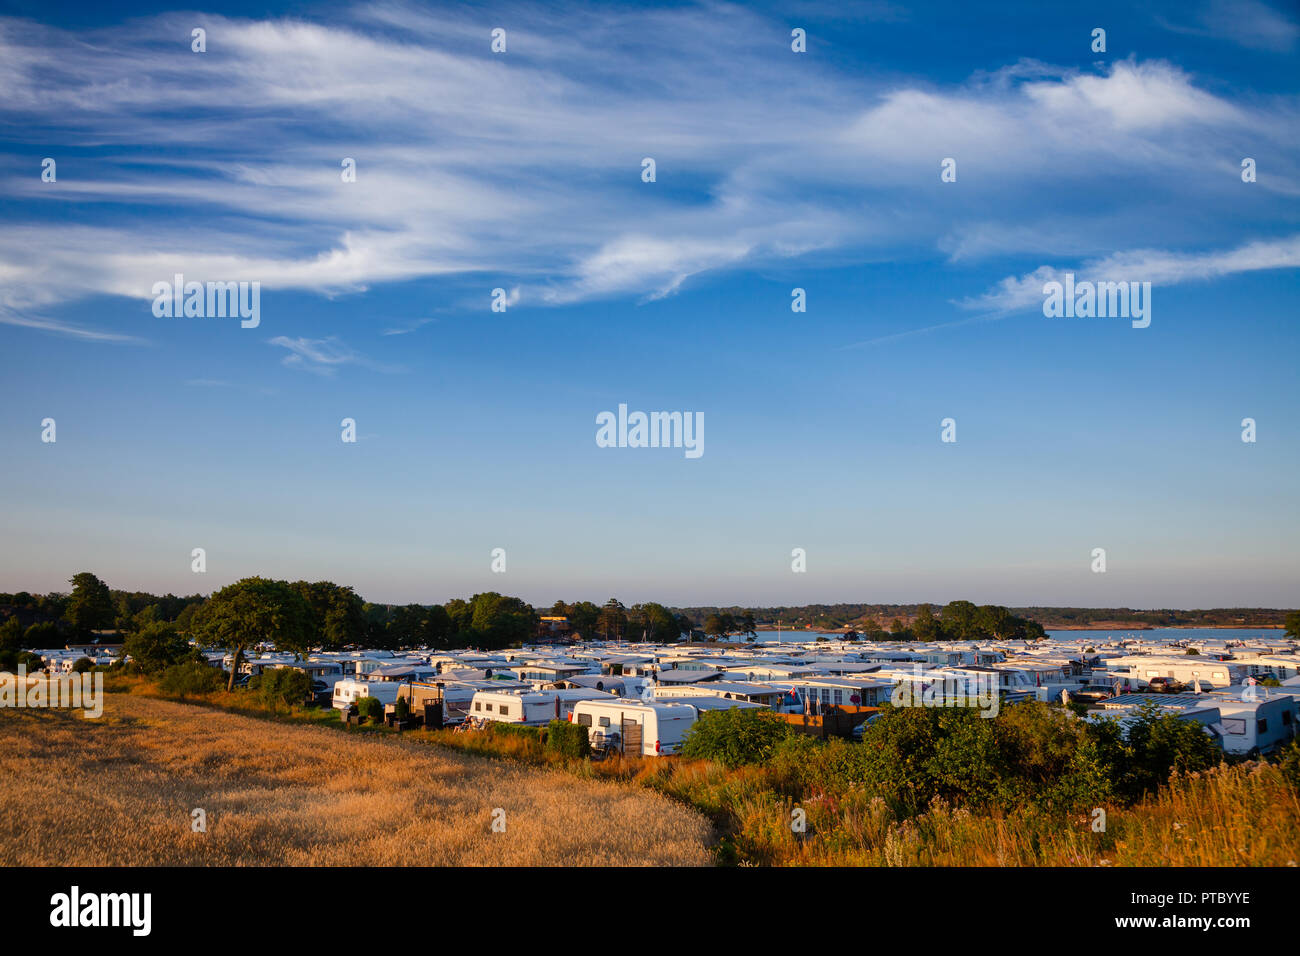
[190,578,316,689]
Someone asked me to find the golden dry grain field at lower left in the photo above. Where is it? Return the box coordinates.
[0,693,712,866]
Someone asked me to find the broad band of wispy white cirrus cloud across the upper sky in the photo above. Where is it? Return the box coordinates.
[0,3,1300,343]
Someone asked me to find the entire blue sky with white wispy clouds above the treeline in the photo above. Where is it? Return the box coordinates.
[0,0,1300,607]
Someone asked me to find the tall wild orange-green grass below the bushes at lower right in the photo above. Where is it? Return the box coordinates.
[667,763,1300,866]
